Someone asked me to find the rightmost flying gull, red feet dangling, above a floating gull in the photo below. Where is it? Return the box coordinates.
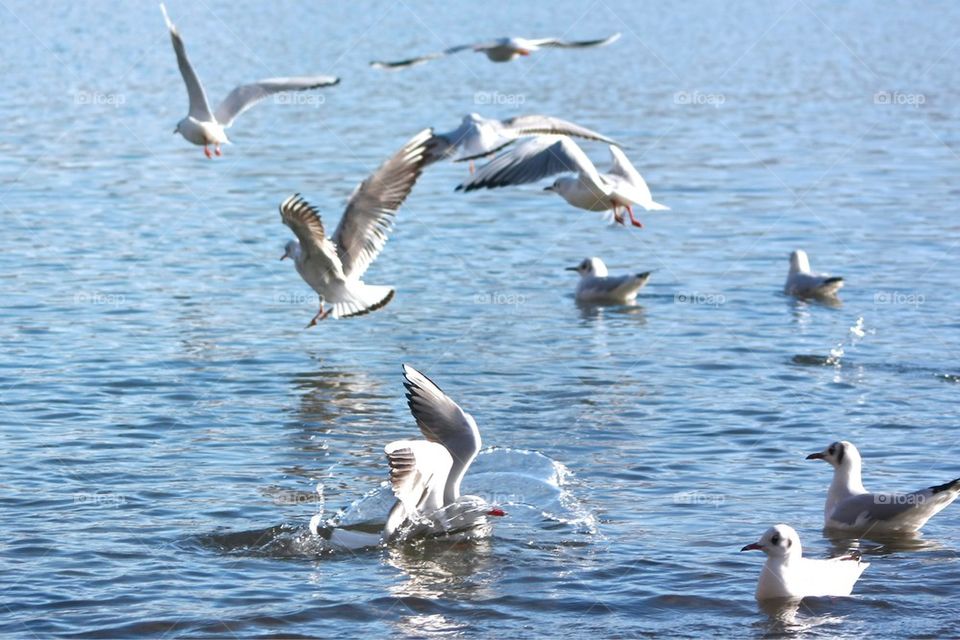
[456,136,670,227]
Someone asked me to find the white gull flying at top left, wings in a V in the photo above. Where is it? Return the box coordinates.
[160,3,340,158]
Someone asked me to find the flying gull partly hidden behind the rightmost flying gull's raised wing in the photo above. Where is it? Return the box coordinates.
[429,113,619,173]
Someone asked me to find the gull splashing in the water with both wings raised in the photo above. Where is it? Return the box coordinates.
[310,365,506,548]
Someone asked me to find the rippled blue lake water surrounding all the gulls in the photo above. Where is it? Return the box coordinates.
[0,0,960,638]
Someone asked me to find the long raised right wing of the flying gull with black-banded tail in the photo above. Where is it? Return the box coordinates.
[333,129,432,278]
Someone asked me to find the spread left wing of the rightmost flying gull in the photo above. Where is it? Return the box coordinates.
[457,136,601,191]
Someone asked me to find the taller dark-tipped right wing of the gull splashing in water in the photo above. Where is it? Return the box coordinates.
[403,365,480,505]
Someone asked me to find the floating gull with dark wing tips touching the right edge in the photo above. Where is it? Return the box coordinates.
[807,440,960,535]
